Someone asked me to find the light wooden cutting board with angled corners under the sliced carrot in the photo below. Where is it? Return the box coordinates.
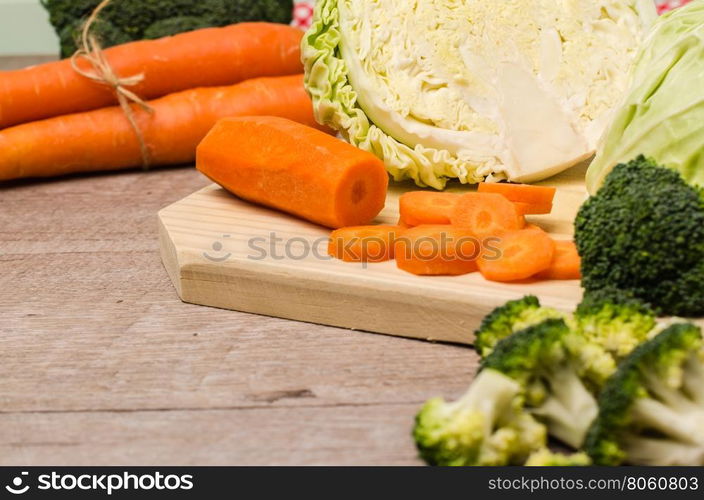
[159,165,586,343]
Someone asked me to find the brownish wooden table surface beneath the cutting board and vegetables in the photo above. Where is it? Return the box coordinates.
[0,54,477,465]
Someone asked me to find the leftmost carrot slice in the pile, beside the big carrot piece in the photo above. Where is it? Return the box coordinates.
[328,226,403,262]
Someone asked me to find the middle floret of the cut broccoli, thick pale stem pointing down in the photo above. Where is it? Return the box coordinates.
[482,319,614,448]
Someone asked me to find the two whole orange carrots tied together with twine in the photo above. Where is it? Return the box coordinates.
[0,23,320,181]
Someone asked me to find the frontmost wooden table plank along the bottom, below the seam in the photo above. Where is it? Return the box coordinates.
[0,404,419,466]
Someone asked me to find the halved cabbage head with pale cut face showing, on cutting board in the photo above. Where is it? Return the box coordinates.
[303,0,657,189]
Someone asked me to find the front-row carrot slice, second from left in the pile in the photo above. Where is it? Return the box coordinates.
[394,225,481,275]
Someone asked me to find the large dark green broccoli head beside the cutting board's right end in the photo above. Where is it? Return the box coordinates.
[575,156,704,316]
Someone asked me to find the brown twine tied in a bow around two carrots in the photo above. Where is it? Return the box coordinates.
[71,0,154,170]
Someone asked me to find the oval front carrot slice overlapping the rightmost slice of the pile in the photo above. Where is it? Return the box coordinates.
[478,227,555,281]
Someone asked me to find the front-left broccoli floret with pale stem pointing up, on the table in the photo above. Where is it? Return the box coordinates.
[413,369,547,466]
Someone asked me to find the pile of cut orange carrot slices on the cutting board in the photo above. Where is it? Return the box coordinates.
[328,183,580,282]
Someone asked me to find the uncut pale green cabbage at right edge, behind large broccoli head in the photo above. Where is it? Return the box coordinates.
[587,0,704,193]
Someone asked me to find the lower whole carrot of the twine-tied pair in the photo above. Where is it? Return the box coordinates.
[0,75,328,181]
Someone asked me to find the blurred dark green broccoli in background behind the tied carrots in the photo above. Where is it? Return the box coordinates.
[41,0,293,57]
